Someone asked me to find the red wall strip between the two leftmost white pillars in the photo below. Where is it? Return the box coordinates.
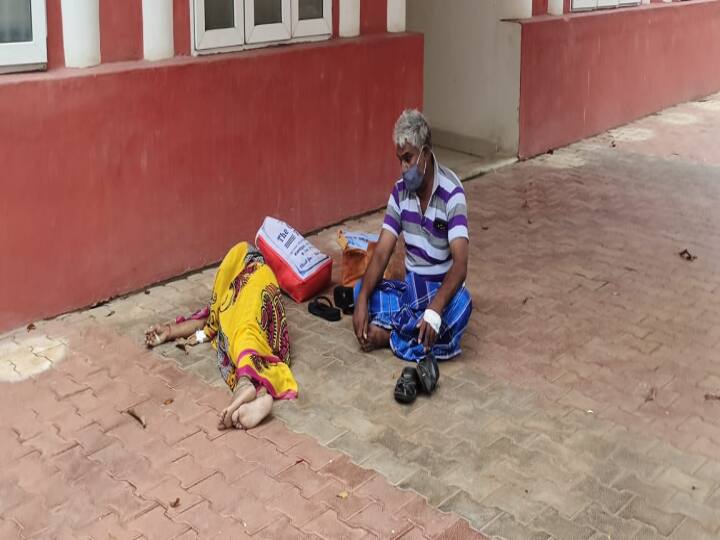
[100,0,143,62]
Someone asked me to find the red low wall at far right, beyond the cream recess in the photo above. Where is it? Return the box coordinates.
[519,0,720,158]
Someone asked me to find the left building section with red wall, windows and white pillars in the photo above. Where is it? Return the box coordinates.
[0,0,423,330]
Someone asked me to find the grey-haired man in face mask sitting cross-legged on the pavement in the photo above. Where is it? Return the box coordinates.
[353,110,472,368]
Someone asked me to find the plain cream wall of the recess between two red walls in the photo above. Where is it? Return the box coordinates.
[407,0,532,154]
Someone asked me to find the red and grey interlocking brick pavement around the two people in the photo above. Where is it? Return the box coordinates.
[0,96,720,540]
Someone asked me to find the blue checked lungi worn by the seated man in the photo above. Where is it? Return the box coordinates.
[355,272,472,362]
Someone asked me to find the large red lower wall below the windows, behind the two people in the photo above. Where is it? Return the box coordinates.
[0,34,423,331]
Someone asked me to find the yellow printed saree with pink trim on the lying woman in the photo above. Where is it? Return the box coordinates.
[204,242,298,399]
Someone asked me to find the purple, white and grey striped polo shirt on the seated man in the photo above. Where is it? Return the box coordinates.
[383,156,468,280]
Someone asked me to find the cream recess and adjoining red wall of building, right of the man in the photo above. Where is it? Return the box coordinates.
[407,0,720,158]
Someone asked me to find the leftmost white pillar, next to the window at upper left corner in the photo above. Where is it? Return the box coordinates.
[61,0,100,67]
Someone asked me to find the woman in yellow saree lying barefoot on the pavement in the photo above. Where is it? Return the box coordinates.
[145,242,297,429]
